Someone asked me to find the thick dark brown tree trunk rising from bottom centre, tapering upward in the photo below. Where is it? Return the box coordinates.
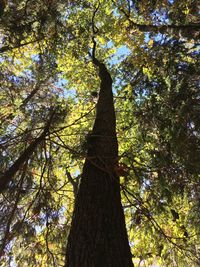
[65,58,133,267]
